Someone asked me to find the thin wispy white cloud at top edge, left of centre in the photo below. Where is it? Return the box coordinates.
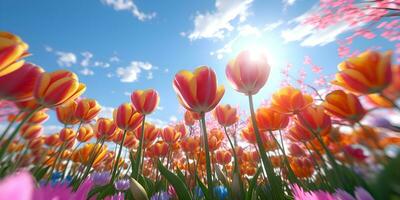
[101,0,156,21]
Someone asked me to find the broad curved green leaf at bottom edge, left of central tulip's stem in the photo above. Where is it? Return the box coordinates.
[157,160,192,200]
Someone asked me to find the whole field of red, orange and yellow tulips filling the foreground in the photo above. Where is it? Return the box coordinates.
[0,32,400,200]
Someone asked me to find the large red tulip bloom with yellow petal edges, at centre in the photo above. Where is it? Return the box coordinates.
[173,66,225,113]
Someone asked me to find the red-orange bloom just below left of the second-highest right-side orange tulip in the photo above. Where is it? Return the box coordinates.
[296,105,332,136]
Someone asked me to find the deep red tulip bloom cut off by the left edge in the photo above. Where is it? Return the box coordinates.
[0,63,43,101]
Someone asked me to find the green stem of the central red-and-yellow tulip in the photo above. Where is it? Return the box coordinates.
[200,112,214,199]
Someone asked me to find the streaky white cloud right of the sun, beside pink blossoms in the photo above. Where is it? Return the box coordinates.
[281,6,361,46]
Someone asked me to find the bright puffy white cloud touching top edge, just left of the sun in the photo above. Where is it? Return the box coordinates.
[186,0,253,40]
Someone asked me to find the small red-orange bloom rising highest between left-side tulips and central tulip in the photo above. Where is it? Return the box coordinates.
[131,89,160,115]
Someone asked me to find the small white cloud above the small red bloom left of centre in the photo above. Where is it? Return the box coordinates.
[116,61,153,83]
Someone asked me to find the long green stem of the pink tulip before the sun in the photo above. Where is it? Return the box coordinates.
[249,95,285,200]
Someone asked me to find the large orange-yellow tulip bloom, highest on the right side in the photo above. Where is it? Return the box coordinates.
[333,51,392,94]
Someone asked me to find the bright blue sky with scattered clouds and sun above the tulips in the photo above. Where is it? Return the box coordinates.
[0,0,394,133]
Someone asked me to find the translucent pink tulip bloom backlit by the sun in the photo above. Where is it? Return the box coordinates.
[225,50,271,95]
